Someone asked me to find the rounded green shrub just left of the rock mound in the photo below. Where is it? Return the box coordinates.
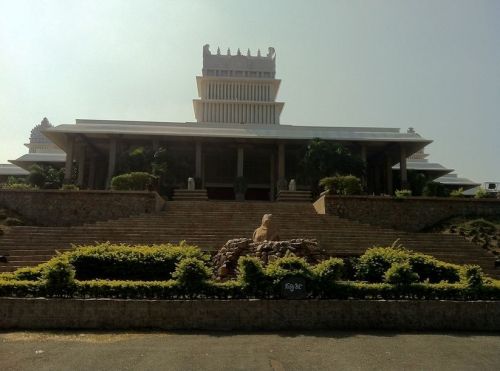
[172,258,211,297]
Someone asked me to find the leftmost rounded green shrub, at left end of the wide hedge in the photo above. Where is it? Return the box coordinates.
[42,256,75,296]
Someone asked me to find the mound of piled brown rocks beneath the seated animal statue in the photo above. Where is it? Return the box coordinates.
[212,238,328,279]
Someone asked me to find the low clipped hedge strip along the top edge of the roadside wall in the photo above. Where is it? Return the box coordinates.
[0,280,500,300]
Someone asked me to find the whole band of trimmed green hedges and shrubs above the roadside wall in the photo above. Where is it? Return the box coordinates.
[0,243,500,300]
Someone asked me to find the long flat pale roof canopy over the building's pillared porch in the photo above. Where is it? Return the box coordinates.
[43,120,432,163]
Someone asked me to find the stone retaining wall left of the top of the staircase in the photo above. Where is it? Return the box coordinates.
[0,190,165,226]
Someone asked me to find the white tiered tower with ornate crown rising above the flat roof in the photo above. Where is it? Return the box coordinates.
[193,44,284,124]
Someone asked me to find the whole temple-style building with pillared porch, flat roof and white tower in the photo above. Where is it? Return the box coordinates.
[1,45,478,200]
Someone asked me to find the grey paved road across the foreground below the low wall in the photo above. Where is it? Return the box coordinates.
[0,332,500,371]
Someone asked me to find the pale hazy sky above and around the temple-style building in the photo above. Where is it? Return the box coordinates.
[0,0,500,181]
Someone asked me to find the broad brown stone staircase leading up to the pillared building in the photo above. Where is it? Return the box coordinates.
[0,201,500,278]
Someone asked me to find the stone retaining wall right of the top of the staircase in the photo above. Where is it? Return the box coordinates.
[314,195,500,232]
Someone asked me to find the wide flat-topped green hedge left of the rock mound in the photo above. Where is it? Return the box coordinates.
[67,242,206,281]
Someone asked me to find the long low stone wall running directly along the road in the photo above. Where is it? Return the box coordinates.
[0,298,500,331]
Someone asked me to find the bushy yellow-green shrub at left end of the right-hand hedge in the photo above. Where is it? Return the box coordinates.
[356,247,410,282]
